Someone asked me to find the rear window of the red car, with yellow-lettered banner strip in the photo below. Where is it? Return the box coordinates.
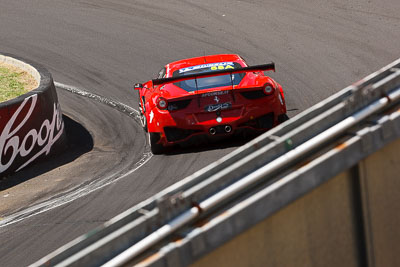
[172,62,245,92]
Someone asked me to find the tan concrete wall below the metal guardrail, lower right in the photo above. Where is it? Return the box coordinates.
[189,137,400,267]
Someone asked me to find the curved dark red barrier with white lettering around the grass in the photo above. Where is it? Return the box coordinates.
[0,54,66,176]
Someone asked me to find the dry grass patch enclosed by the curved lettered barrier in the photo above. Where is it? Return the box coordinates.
[0,62,39,102]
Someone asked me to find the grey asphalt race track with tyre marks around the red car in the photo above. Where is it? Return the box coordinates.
[0,0,400,266]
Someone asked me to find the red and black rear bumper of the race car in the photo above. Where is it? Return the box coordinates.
[148,97,286,146]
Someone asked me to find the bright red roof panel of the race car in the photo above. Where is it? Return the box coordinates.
[165,54,244,74]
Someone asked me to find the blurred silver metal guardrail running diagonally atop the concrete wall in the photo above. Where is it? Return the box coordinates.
[32,59,400,266]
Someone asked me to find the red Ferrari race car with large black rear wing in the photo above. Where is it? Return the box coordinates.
[134,55,288,154]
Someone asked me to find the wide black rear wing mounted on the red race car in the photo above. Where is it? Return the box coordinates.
[152,62,275,85]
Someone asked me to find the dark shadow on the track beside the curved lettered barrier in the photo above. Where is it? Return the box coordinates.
[0,115,93,191]
